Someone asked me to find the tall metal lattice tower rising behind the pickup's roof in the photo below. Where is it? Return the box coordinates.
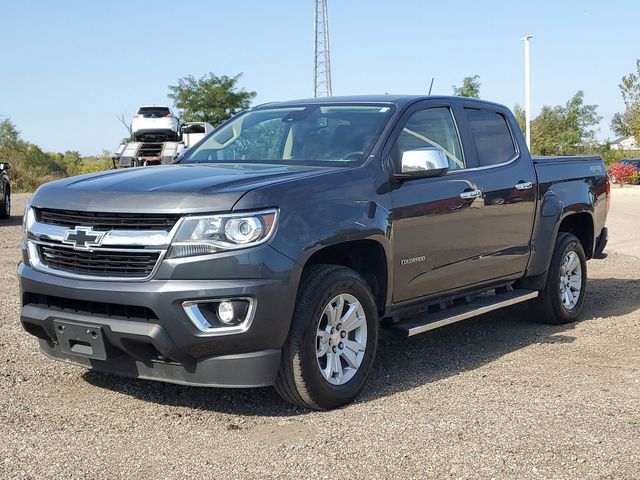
[313,0,331,97]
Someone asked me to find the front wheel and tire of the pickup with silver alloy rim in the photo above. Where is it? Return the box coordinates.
[276,265,378,410]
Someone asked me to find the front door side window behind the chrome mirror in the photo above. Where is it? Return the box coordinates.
[394,107,465,170]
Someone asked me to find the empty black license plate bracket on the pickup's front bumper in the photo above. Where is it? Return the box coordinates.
[53,319,107,360]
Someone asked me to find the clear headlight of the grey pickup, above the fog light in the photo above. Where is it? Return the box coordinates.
[169,210,278,258]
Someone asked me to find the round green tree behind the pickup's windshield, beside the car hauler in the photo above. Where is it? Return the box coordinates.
[169,72,256,126]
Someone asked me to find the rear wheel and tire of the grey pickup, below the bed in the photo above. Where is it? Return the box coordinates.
[530,233,587,325]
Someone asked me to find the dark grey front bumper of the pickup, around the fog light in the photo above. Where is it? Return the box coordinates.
[18,251,295,387]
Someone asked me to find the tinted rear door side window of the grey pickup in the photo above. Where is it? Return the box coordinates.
[465,108,516,166]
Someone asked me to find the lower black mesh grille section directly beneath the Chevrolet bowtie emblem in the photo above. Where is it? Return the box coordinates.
[38,245,160,278]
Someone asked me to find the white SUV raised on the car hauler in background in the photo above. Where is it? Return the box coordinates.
[131,105,180,142]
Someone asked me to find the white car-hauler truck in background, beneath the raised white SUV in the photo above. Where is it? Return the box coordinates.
[111,122,213,168]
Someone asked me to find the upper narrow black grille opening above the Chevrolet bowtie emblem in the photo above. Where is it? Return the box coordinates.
[36,208,180,231]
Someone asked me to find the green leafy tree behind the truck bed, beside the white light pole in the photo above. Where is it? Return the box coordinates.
[531,90,602,155]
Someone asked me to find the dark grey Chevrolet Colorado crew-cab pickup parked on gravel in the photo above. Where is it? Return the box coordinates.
[18,95,610,409]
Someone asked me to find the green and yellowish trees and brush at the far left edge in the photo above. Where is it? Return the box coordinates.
[0,119,112,192]
